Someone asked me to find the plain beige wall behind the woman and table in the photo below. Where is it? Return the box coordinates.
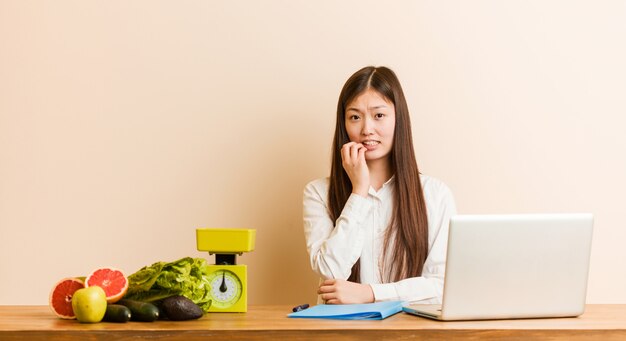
[0,0,626,304]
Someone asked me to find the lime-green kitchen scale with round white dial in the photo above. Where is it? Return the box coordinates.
[196,228,256,313]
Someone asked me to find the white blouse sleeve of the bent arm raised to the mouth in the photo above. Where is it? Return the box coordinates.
[303,181,372,279]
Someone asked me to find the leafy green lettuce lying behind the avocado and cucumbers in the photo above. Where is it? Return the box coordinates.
[124,257,211,312]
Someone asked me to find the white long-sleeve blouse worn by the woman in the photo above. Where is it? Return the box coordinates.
[303,175,456,303]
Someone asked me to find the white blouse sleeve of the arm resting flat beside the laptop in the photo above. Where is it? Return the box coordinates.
[371,179,456,304]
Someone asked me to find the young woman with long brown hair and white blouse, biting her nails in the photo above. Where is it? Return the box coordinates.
[303,67,456,304]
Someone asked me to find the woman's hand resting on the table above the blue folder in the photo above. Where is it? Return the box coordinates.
[317,279,374,304]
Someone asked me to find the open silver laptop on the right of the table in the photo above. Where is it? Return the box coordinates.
[402,213,593,321]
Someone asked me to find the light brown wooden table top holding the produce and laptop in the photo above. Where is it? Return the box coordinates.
[0,304,626,341]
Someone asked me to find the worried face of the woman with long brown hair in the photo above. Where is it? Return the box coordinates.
[345,89,396,161]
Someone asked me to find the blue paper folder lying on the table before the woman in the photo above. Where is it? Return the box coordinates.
[287,301,402,320]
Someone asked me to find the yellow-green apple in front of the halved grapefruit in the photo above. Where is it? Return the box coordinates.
[72,286,107,323]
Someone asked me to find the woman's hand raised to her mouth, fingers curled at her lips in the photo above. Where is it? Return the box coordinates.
[341,142,370,197]
